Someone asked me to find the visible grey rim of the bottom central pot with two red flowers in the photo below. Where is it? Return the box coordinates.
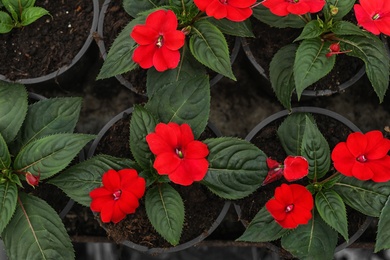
[87,108,231,255]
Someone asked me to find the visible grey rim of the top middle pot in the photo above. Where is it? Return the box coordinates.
[97,0,241,95]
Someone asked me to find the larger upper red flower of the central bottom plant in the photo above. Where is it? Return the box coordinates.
[146,122,209,186]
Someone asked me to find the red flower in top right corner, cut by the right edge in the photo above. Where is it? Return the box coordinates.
[354,0,390,35]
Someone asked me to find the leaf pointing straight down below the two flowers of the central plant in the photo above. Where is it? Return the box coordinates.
[145,183,184,246]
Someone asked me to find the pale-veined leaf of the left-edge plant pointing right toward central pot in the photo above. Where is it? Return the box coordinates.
[14,134,95,180]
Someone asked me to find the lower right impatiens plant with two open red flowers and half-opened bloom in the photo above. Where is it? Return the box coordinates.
[238,113,390,259]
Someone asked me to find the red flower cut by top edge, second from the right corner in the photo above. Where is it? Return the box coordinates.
[263,0,325,16]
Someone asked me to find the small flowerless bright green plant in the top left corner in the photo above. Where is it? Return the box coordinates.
[0,0,49,33]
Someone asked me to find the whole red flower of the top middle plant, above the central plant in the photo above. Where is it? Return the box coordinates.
[130,10,185,72]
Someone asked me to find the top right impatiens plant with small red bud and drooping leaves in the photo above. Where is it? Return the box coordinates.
[253,0,390,109]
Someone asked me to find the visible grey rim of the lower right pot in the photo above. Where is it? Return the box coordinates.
[234,107,374,254]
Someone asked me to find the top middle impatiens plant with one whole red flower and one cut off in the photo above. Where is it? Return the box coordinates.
[97,0,256,95]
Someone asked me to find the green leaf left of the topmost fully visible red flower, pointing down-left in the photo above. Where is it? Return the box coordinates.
[96,16,146,79]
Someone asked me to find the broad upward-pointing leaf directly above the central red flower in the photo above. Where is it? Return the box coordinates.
[145,76,210,138]
